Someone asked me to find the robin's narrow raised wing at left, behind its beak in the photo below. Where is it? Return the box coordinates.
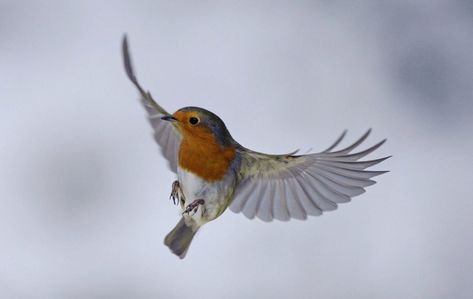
[122,36,181,172]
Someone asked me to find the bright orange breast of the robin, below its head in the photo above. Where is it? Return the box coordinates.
[178,134,235,181]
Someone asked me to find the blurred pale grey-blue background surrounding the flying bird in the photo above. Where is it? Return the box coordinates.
[0,0,473,299]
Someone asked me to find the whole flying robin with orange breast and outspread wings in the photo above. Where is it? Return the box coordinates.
[122,37,389,259]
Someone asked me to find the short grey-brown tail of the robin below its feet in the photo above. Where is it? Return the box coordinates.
[164,217,199,259]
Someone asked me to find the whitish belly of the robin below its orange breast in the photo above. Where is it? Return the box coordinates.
[177,167,235,225]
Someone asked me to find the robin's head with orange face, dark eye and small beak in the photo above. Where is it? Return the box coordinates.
[161,107,234,146]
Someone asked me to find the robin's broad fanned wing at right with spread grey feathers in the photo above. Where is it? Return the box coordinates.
[230,130,389,221]
